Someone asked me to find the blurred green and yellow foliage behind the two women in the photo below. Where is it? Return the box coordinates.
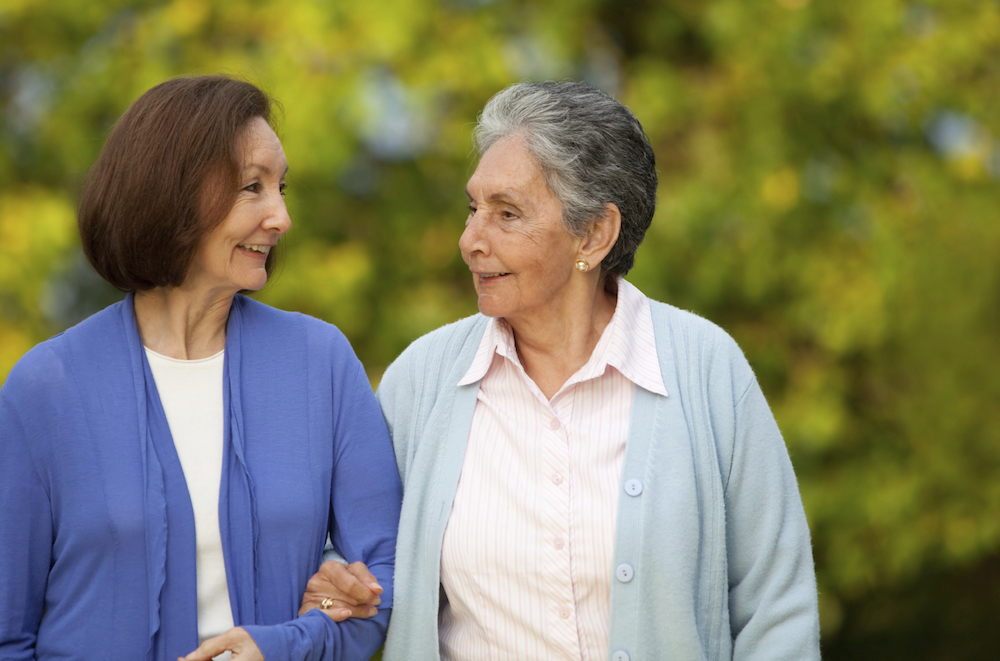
[0,0,1000,659]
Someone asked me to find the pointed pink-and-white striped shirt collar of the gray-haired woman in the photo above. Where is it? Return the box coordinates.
[457,278,667,397]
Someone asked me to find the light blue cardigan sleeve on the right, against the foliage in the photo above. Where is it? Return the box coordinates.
[722,356,820,661]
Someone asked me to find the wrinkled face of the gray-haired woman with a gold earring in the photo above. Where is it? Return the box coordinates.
[458,136,583,325]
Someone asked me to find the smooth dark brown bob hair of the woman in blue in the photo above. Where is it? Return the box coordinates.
[77,76,282,291]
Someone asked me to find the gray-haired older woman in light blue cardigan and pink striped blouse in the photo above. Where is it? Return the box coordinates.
[300,83,819,661]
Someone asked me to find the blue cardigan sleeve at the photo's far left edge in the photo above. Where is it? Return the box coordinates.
[0,390,52,659]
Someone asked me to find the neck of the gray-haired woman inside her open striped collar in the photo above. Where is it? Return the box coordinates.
[507,278,617,399]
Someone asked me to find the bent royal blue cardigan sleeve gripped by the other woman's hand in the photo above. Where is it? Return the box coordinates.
[244,362,402,661]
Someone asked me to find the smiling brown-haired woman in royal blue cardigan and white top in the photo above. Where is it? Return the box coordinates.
[0,76,401,661]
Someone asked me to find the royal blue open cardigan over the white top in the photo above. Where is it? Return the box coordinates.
[0,295,402,661]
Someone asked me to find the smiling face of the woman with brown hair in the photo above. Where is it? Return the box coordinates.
[184,117,292,293]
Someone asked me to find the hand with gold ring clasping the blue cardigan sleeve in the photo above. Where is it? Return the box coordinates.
[299,560,382,622]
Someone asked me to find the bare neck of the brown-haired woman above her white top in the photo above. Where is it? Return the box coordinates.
[134,286,235,360]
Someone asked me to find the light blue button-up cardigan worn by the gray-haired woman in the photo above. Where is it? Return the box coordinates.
[377,301,819,661]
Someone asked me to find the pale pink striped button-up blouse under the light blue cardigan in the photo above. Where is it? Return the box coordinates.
[440,280,667,661]
